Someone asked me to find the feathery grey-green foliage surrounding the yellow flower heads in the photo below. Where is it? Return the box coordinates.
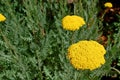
[0,0,120,80]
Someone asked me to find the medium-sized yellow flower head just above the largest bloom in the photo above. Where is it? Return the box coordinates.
[62,15,85,31]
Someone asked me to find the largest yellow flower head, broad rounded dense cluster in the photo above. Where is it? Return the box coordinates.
[67,40,106,70]
